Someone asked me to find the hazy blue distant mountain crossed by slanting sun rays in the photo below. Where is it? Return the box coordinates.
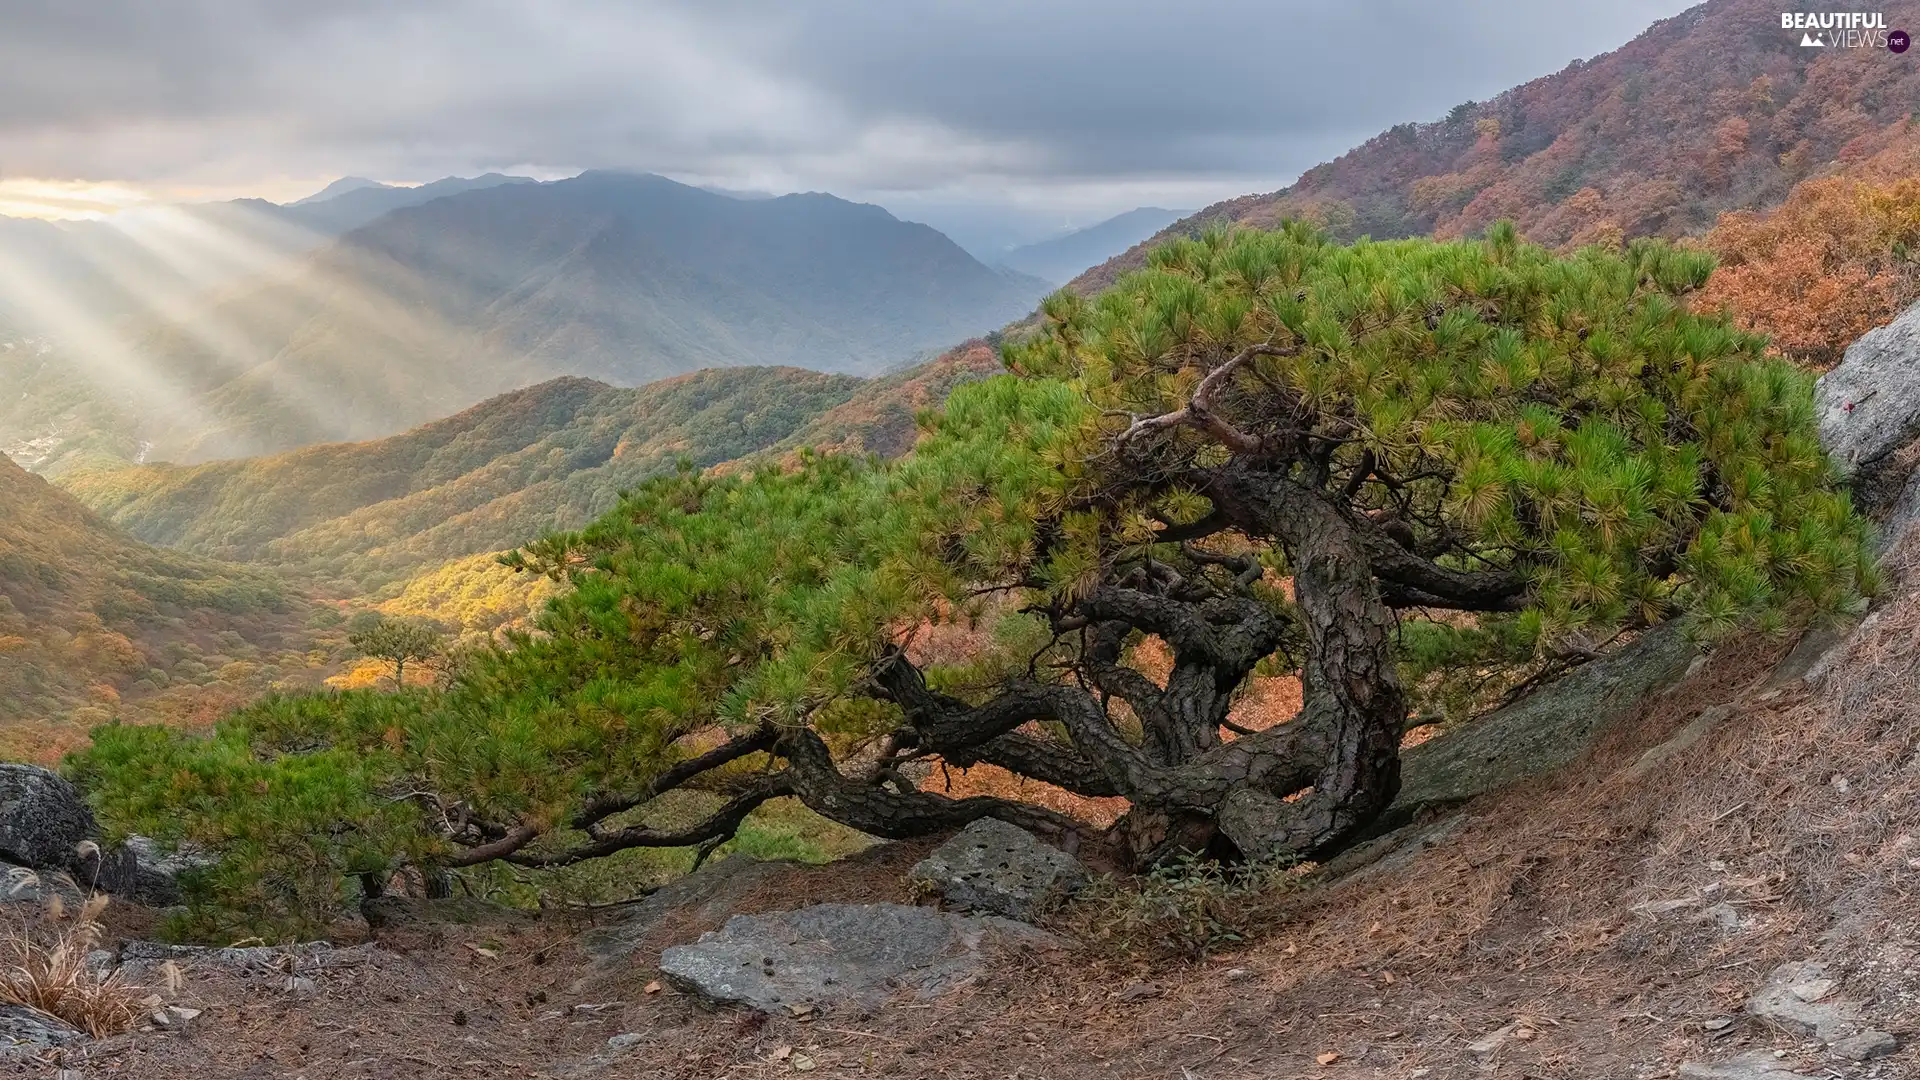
[0,173,1046,461]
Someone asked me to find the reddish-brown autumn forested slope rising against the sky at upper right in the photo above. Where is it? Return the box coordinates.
[1073,0,1920,292]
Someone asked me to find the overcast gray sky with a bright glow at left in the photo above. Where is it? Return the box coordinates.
[0,0,1686,243]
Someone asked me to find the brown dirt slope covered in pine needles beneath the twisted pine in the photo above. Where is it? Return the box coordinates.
[21,584,1920,1080]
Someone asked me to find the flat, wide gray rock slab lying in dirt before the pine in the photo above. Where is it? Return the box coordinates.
[660,903,1066,1015]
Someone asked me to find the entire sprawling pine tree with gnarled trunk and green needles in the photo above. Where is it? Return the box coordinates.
[71,223,1872,919]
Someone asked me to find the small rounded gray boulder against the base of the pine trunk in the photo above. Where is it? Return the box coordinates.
[908,817,1087,920]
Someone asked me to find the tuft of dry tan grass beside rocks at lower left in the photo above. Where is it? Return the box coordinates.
[0,896,146,1038]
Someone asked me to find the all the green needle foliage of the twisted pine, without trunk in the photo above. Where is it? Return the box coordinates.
[71,225,1872,922]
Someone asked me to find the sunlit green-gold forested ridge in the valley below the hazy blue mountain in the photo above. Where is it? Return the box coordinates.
[61,367,862,590]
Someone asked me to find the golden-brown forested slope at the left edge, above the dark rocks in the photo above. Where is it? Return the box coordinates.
[0,457,307,759]
